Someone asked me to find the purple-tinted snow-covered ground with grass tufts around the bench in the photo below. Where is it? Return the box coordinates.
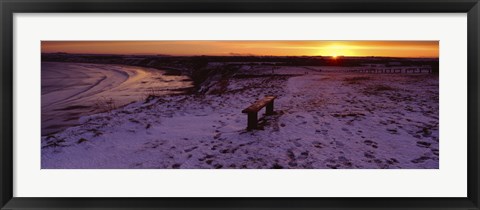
[41,66,439,169]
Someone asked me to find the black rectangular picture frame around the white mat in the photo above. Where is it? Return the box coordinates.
[0,0,480,209]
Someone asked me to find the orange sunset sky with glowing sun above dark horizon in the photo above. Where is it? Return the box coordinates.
[42,41,439,58]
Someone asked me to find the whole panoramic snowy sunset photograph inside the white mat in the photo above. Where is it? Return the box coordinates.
[39,40,440,169]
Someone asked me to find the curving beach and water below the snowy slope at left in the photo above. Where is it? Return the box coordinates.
[42,62,190,136]
